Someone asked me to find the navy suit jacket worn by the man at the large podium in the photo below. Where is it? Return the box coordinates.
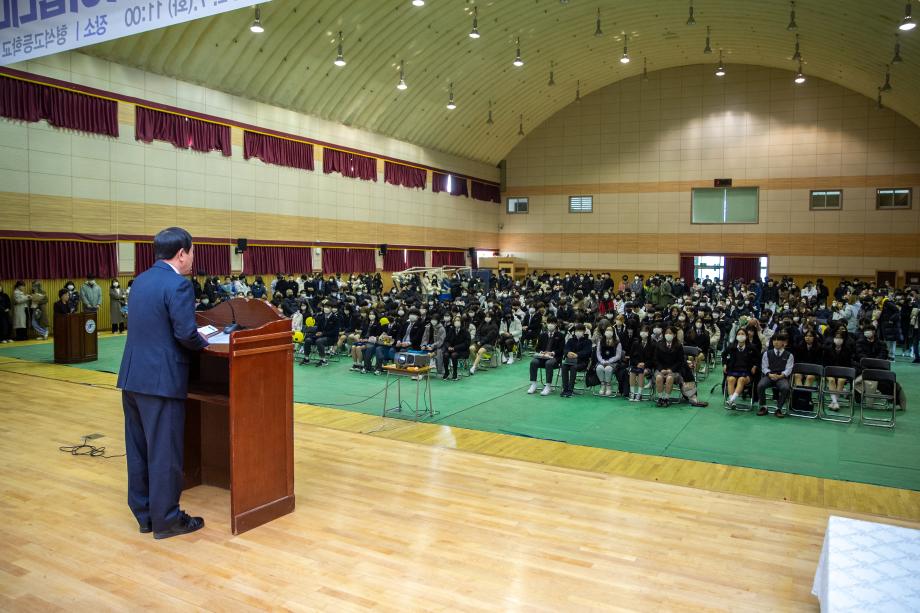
[118,260,208,400]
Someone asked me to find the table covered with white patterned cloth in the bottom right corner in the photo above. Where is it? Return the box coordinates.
[811,515,920,613]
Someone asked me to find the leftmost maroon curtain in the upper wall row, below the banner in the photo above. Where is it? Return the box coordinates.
[0,76,118,136]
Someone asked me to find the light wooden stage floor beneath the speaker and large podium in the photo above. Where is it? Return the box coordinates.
[0,360,920,611]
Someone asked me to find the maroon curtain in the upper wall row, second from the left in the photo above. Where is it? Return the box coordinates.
[134,106,230,157]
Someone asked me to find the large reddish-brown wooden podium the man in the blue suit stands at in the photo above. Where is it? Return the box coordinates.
[184,298,294,534]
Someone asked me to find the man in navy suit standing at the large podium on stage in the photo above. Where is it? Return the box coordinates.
[118,228,208,539]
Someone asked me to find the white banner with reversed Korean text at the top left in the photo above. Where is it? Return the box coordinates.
[0,0,269,66]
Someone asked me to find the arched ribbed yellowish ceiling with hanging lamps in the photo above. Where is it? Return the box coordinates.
[84,0,920,163]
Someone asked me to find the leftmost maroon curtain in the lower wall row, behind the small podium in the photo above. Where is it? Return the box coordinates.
[0,239,118,279]
